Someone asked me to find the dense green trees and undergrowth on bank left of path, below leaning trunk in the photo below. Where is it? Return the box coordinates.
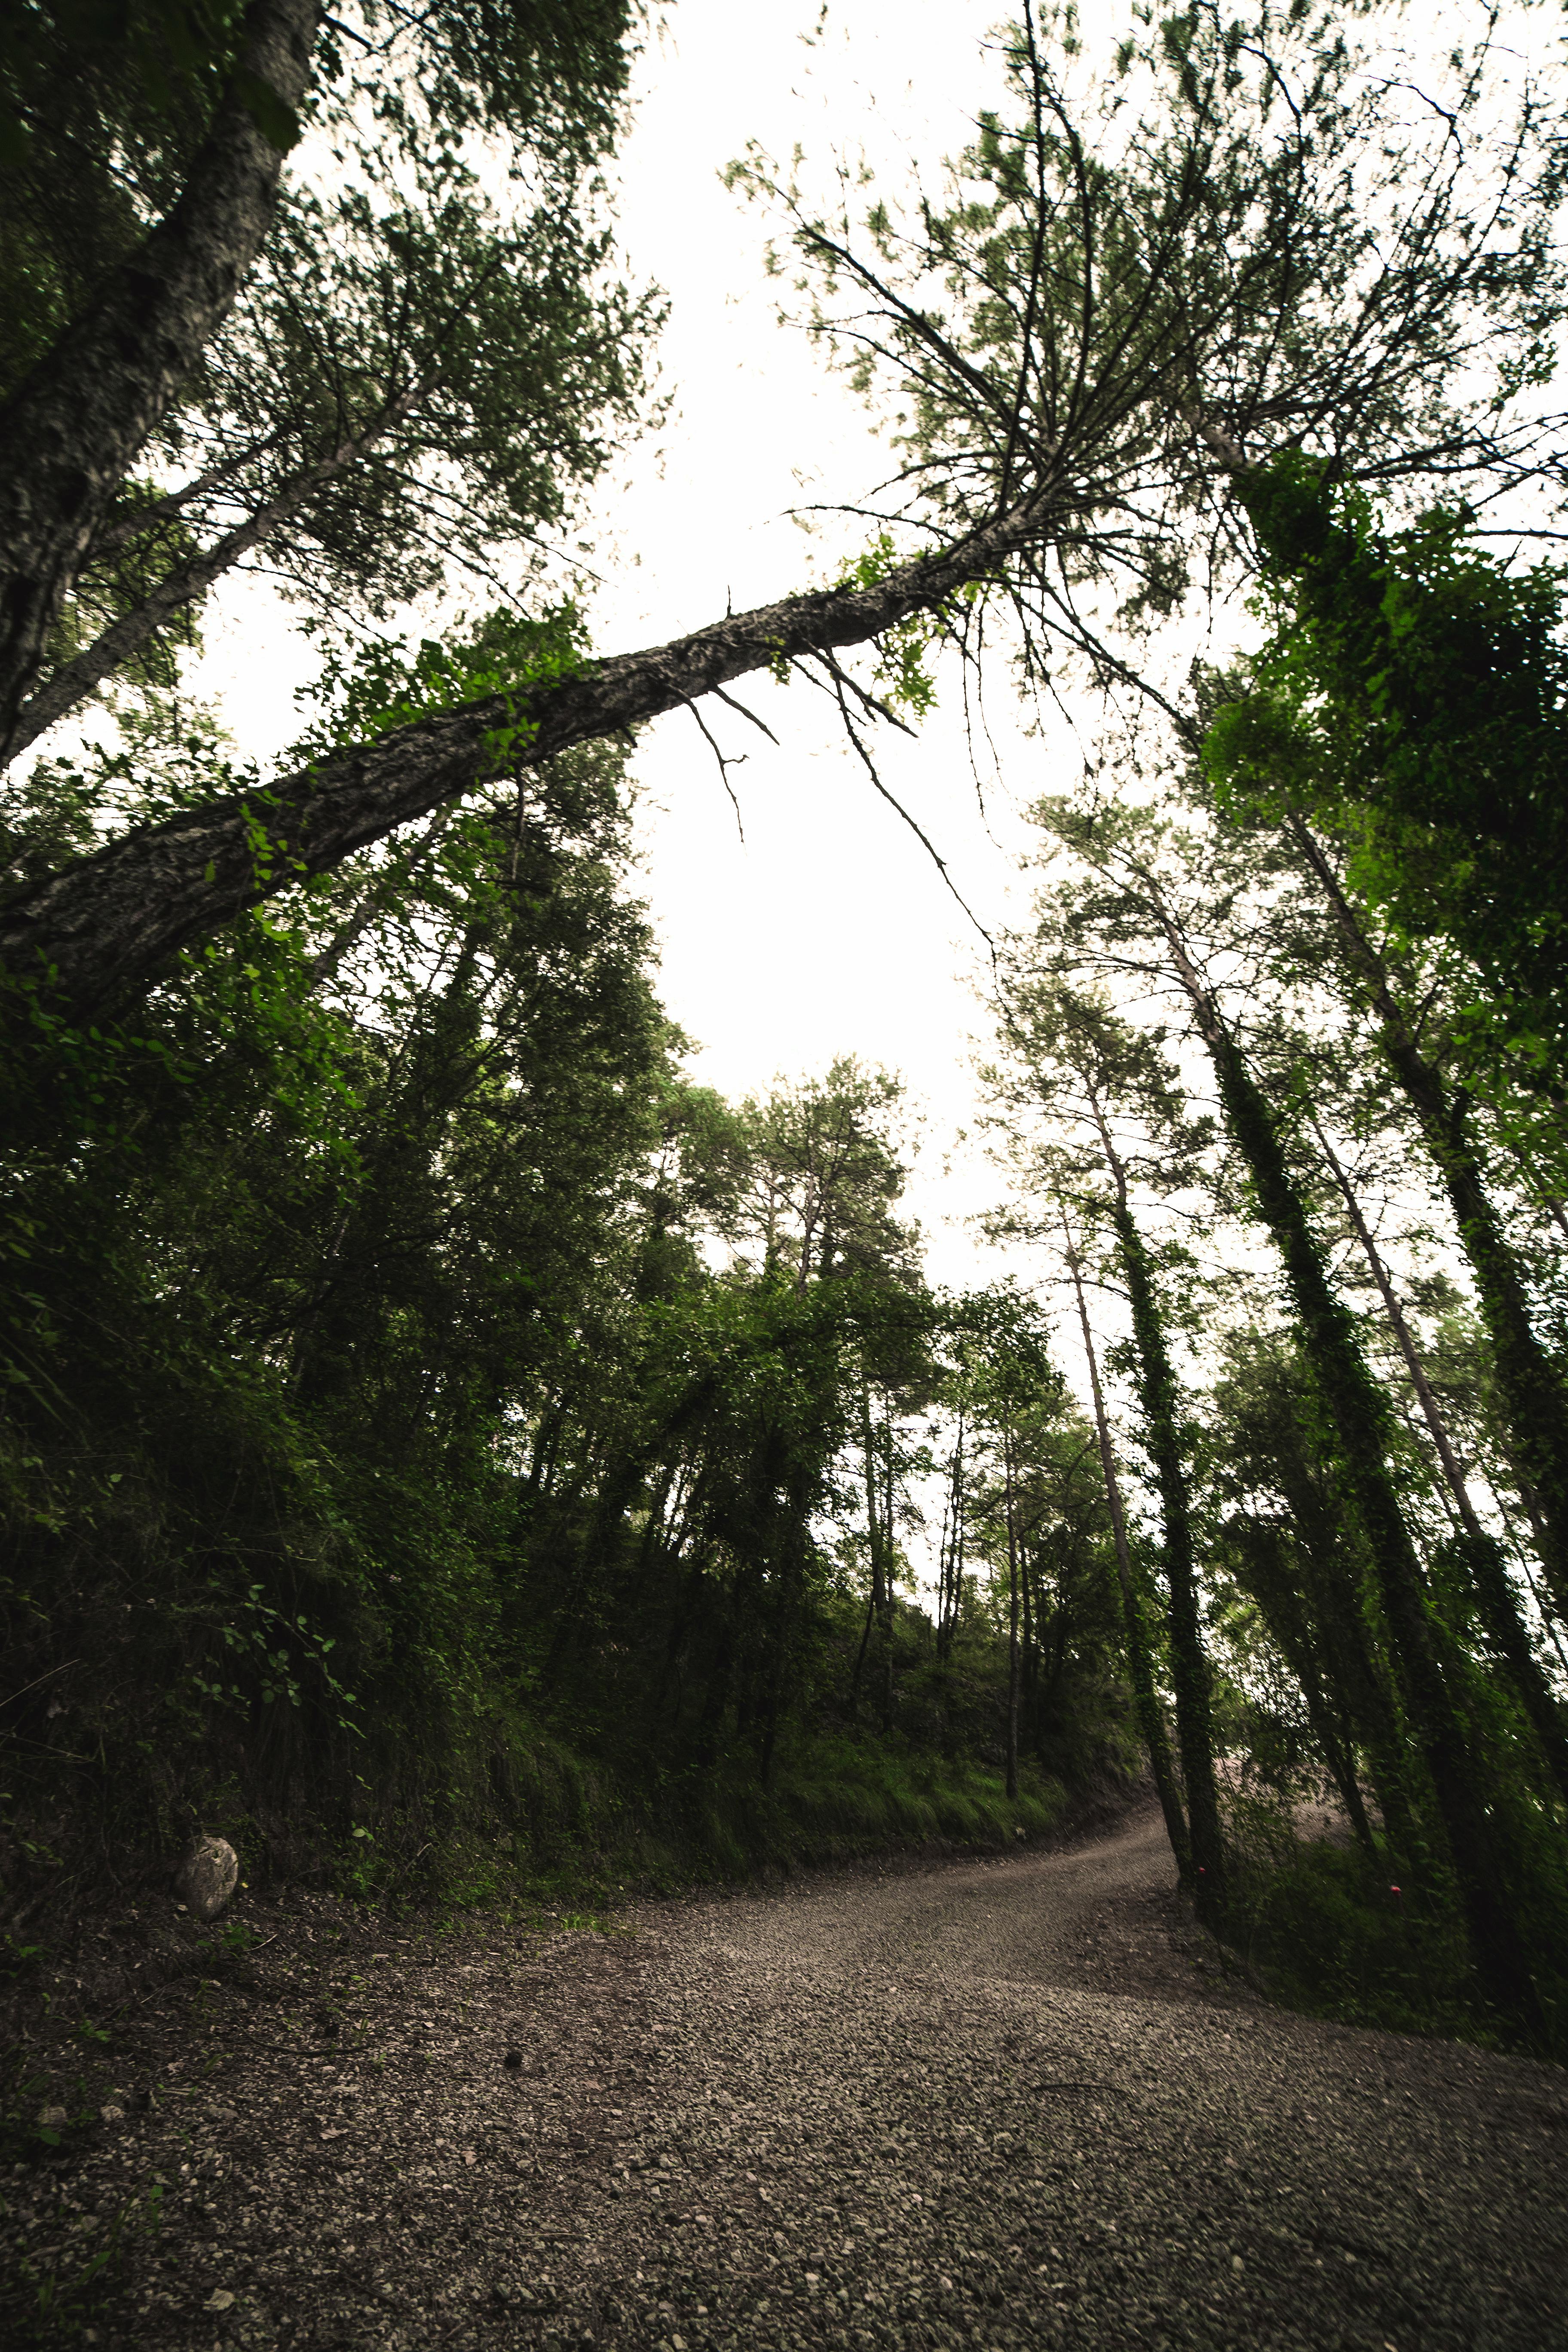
[0,668,1124,1908]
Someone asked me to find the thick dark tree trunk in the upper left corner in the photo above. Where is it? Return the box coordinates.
[0,0,322,746]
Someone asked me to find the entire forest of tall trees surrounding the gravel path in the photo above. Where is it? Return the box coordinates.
[0,0,1568,2053]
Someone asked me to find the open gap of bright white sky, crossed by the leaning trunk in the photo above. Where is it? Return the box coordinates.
[597,0,1051,1280]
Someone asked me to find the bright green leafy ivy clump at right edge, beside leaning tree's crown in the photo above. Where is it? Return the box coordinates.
[1204,452,1568,1075]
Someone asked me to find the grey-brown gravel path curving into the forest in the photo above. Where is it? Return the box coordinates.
[7,1813,1568,2352]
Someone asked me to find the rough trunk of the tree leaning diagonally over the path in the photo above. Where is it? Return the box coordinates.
[0,489,1058,1018]
